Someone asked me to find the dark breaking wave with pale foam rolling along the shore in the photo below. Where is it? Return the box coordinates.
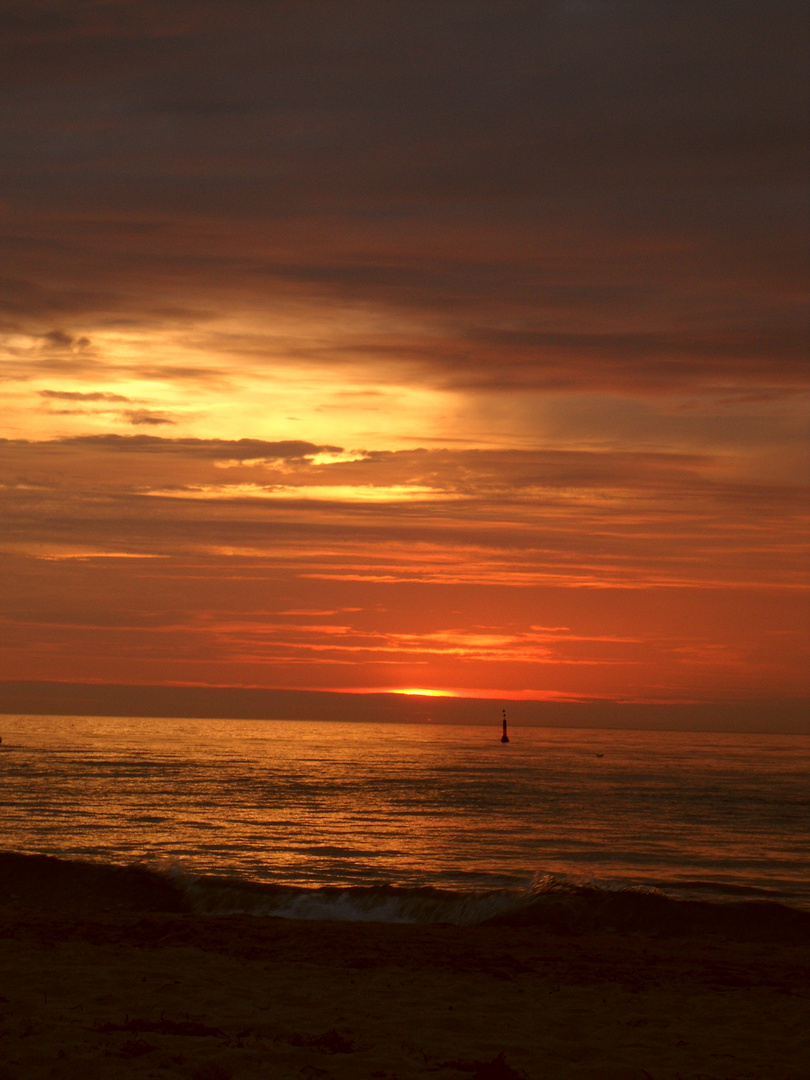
[0,852,810,942]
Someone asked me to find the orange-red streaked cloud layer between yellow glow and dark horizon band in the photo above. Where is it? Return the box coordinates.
[0,436,810,701]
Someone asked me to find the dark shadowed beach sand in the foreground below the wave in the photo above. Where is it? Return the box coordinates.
[0,908,810,1080]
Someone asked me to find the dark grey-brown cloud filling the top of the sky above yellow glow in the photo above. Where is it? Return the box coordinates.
[0,0,808,388]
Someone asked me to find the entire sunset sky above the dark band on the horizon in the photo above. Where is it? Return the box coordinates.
[0,0,810,705]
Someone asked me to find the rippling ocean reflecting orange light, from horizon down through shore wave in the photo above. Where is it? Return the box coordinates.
[0,716,810,923]
